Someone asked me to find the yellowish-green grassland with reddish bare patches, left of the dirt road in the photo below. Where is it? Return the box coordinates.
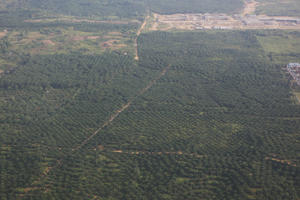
[3,27,133,55]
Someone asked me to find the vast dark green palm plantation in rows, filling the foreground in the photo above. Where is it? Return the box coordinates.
[0,31,300,200]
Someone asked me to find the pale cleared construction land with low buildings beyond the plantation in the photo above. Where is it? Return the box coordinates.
[149,1,300,31]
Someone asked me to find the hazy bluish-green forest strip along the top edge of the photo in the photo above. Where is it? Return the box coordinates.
[0,0,243,18]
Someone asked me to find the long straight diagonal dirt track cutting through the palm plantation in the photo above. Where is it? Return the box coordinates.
[19,65,171,198]
